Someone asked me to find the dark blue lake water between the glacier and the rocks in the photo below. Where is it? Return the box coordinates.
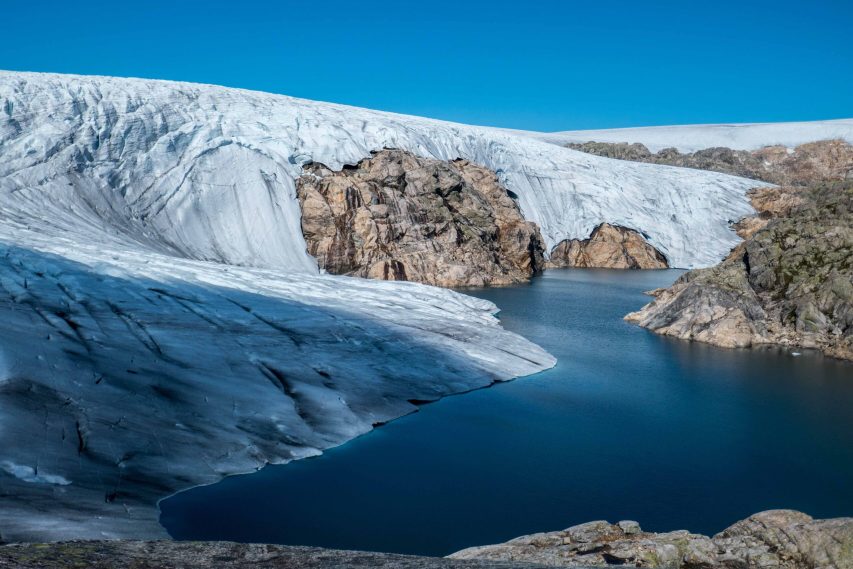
[161,270,853,555]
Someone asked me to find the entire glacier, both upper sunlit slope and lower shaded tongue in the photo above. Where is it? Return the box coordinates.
[0,72,776,541]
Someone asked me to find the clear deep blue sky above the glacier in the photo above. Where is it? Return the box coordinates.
[0,0,853,130]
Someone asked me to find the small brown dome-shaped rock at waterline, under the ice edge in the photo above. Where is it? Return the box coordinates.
[548,223,669,269]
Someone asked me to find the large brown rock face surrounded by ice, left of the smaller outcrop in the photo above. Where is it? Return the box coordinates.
[296,150,544,287]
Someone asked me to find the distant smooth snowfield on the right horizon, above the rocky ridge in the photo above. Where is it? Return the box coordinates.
[517,119,853,152]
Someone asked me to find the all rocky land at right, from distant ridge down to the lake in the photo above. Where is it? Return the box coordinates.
[568,140,853,360]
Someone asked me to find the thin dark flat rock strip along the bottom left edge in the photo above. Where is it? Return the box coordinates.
[0,541,552,569]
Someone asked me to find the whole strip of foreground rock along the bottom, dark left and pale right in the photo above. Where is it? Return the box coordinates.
[5,510,853,569]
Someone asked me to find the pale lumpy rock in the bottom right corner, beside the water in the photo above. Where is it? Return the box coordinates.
[451,510,853,569]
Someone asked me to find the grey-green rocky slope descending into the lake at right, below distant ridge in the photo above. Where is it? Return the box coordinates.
[625,182,853,359]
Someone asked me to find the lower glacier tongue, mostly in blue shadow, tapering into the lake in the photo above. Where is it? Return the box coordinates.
[0,244,554,540]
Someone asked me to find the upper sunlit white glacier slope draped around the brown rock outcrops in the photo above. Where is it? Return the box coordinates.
[0,72,755,272]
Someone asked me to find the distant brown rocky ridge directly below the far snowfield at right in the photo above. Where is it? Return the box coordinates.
[567,140,853,186]
